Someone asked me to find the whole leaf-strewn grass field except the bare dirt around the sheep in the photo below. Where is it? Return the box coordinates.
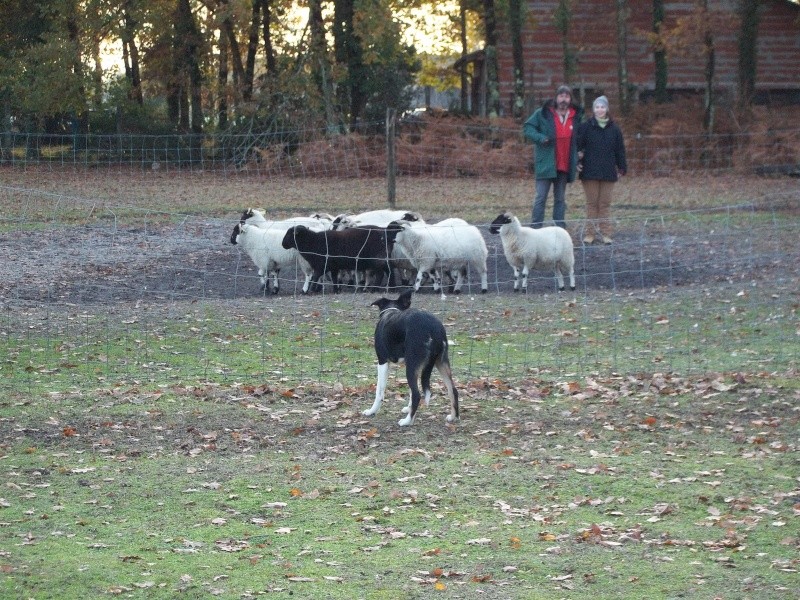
[0,170,800,600]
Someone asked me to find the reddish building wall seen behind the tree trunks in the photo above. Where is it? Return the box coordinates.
[498,0,800,112]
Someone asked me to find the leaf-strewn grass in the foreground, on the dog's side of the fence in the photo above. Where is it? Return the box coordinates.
[0,374,800,598]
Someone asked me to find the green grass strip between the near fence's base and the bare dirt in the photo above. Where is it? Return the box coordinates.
[0,286,798,392]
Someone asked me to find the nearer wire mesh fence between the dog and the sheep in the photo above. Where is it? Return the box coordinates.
[0,186,800,391]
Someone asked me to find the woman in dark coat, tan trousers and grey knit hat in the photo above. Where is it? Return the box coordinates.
[577,96,628,244]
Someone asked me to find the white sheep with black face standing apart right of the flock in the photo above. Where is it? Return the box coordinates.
[489,212,575,292]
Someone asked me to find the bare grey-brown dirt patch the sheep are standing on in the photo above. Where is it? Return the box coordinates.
[0,211,800,305]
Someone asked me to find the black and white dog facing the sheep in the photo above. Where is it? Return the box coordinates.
[363,290,458,427]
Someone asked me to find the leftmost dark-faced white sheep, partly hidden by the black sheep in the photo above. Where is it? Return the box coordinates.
[233,223,314,294]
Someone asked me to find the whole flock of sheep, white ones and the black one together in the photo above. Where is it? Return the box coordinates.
[230,208,575,294]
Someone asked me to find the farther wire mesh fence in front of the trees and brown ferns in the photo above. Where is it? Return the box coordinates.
[0,118,800,177]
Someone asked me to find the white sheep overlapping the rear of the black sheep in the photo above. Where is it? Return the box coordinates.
[395,218,489,294]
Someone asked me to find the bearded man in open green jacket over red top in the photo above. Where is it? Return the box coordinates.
[522,85,583,229]
